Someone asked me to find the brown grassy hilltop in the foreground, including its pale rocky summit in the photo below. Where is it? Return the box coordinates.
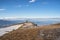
[0,22,60,40]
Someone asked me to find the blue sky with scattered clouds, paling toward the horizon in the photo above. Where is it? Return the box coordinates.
[0,0,60,18]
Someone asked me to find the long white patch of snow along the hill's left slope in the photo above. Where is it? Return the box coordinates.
[0,24,21,36]
